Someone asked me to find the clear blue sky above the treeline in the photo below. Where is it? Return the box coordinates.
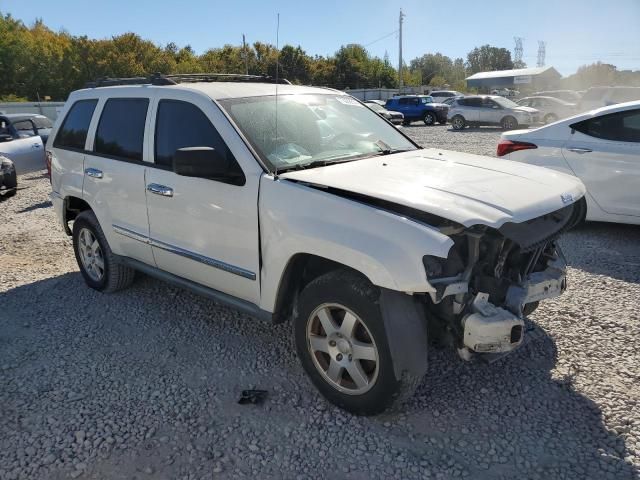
[0,0,640,75]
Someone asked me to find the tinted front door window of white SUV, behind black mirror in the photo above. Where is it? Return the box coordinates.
[155,100,244,184]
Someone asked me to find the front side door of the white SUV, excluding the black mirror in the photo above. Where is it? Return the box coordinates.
[146,90,263,304]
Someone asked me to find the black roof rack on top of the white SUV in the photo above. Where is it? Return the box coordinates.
[85,73,291,88]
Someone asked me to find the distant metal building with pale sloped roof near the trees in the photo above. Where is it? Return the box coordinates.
[466,67,562,88]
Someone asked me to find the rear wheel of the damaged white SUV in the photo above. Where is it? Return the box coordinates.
[73,210,135,293]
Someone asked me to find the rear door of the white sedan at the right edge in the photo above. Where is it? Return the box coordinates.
[562,109,640,216]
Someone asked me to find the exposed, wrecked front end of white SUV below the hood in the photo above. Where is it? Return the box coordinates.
[423,199,586,359]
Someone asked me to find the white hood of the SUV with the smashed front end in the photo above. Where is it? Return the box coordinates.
[280,149,585,228]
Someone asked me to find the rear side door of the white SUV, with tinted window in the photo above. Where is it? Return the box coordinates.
[83,94,154,265]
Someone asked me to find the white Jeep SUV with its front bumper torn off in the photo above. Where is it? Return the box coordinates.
[47,75,584,414]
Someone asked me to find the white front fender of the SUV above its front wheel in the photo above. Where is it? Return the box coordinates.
[259,176,453,311]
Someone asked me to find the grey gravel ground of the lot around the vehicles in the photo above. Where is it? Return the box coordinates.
[0,126,640,480]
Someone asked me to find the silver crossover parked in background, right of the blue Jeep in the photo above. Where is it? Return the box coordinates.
[449,95,540,130]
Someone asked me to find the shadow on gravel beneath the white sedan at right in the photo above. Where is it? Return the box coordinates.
[560,222,640,283]
